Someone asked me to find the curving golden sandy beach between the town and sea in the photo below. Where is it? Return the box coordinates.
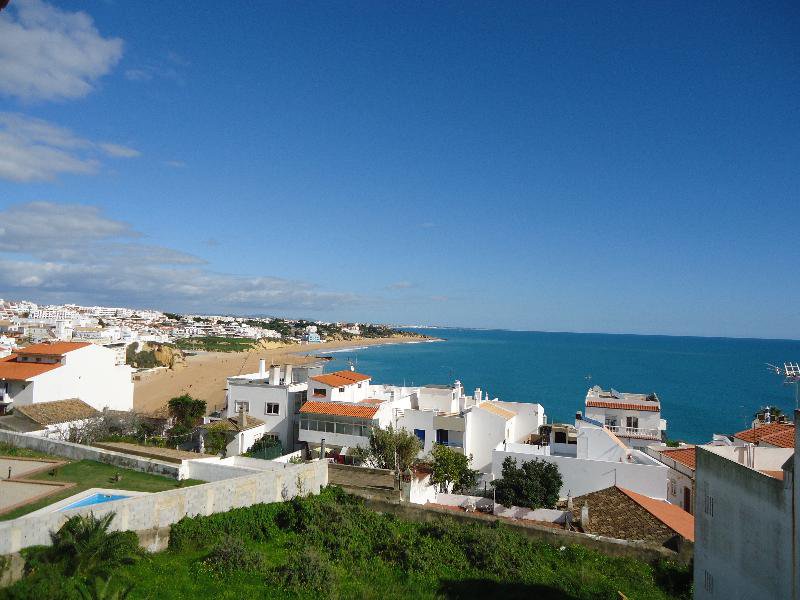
[133,337,440,412]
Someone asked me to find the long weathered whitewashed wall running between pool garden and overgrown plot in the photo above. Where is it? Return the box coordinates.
[0,461,328,555]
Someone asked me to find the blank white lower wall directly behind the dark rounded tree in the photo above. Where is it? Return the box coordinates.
[492,444,669,499]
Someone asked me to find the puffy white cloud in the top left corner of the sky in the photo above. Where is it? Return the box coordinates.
[0,0,123,100]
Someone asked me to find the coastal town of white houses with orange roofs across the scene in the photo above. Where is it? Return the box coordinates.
[0,312,800,598]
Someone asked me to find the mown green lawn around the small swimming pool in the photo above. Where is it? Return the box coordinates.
[0,460,203,521]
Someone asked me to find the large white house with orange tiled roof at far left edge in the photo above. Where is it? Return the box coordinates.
[0,342,133,414]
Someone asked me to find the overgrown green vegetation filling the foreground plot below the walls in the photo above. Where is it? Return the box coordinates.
[0,488,690,600]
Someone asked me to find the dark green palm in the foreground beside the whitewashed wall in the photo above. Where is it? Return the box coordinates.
[48,513,139,578]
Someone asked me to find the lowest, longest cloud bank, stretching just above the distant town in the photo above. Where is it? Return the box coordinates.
[0,202,361,312]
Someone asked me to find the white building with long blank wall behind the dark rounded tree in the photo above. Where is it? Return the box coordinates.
[492,419,669,500]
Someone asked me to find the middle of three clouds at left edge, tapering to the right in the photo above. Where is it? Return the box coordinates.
[0,112,140,181]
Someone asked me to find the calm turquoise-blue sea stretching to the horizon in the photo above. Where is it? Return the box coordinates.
[326,329,800,442]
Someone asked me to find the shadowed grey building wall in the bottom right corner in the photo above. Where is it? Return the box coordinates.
[694,447,796,600]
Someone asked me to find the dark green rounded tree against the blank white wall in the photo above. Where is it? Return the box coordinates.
[492,456,562,509]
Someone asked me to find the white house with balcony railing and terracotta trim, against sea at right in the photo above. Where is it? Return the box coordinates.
[584,385,667,448]
